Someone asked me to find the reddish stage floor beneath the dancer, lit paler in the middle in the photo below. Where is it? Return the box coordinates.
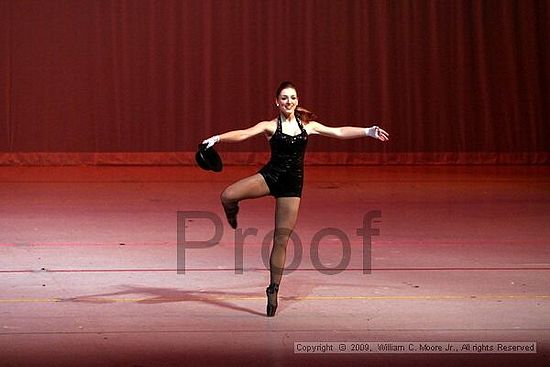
[0,166,550,366]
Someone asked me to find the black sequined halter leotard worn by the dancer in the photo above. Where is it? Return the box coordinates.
[258,116,308,198]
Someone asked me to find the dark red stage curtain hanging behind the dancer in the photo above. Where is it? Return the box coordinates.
[0,0,550,164]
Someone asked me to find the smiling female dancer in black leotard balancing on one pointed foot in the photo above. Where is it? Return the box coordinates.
[203,82,389,317]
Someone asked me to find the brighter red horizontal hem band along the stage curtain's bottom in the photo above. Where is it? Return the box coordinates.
[0,152,550,166]
